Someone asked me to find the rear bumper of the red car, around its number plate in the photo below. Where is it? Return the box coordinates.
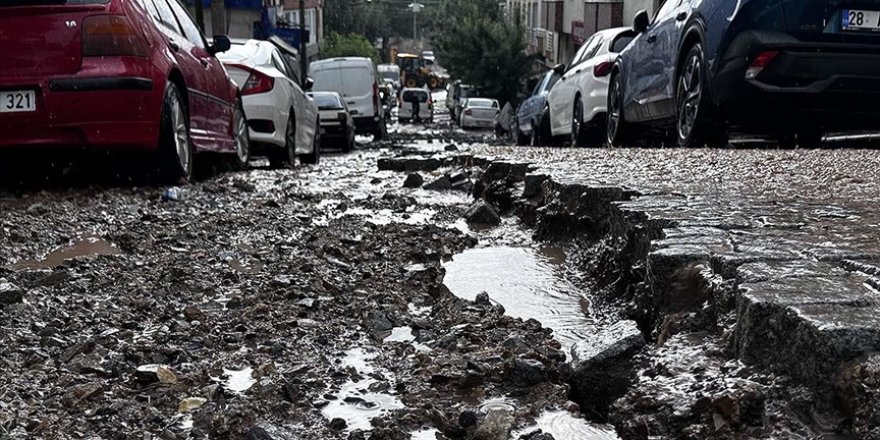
[0,60,165,151]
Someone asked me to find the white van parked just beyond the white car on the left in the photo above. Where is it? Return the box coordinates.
[309,57,387,139]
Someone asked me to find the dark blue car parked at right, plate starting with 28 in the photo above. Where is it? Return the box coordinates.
[607,0,880,147]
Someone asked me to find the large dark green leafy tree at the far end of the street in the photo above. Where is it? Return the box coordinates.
[432,0,534,102]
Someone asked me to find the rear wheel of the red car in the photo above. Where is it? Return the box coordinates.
[156,81,194,183]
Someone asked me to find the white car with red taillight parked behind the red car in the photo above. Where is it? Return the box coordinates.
[219,40,321,168]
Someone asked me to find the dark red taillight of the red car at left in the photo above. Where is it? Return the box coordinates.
[82,15,148,58]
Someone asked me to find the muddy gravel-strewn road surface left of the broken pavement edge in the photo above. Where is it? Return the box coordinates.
[0,124,611,440]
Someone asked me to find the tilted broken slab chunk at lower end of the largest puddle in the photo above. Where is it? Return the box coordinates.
[570,321,645,415]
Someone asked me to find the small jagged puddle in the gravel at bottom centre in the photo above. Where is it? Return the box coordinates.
[321,349,405,431]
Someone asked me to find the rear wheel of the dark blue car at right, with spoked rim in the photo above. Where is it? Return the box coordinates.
[675,43,727,148]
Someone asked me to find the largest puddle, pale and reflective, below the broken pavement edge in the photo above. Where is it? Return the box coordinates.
[444,247,592,353]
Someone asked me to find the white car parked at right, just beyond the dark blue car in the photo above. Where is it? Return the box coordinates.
[546,28,636,146]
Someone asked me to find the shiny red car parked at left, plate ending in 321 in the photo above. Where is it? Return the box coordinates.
[0,0,249,180]
